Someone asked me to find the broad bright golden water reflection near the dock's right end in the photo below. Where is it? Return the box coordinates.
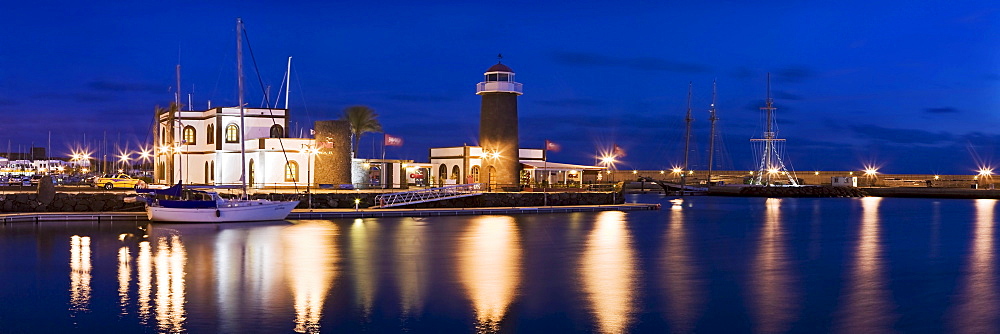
[580,211,639,333]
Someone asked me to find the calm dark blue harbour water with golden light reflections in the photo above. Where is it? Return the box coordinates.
[0,195,1000,334]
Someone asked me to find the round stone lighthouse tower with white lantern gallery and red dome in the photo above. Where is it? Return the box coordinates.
[476,62,522,188]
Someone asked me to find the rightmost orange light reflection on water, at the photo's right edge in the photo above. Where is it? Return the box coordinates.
[954,199,998,333]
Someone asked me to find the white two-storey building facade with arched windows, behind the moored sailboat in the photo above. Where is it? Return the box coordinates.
[154,107,316,189]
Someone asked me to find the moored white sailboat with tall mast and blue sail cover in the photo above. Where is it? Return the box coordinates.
[136,18,299,223]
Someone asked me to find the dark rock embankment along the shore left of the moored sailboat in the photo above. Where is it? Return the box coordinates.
[0,193,143,212]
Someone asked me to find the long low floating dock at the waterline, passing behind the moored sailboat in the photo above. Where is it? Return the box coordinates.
[0,203,660,224]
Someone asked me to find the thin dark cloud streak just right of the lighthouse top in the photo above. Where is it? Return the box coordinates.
[555,52,709,73]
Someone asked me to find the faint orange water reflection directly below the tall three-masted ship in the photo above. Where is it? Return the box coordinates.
[752,198,797,333]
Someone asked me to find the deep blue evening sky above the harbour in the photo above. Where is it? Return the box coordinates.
[0,0,1000,174]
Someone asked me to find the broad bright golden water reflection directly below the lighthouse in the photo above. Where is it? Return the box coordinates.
[458,216,521,333]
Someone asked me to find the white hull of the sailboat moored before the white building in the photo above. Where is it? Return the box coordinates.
[146,200,299,223]
